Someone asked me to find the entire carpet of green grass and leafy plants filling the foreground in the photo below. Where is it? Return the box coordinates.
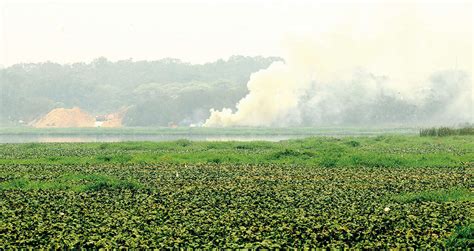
[0,135,474,249]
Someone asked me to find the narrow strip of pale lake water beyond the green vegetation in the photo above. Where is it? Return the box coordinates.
[0,128,418,143]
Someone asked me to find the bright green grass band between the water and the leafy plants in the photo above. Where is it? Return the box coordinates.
[0,135,474,168]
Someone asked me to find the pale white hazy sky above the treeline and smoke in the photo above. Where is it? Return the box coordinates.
[0,0,473,66]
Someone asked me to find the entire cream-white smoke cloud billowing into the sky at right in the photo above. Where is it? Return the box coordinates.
[204,1,474,127]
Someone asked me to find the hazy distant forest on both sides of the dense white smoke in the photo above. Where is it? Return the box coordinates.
[0,56,474,127]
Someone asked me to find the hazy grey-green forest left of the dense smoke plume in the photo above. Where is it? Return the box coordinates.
[0,56,282,126]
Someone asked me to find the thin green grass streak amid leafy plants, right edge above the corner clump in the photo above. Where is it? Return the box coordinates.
[392,188,474,203]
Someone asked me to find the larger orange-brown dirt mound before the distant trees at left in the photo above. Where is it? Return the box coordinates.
[33,107,95,128]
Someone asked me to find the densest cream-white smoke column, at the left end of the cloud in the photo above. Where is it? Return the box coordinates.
[205,43,314,127]
